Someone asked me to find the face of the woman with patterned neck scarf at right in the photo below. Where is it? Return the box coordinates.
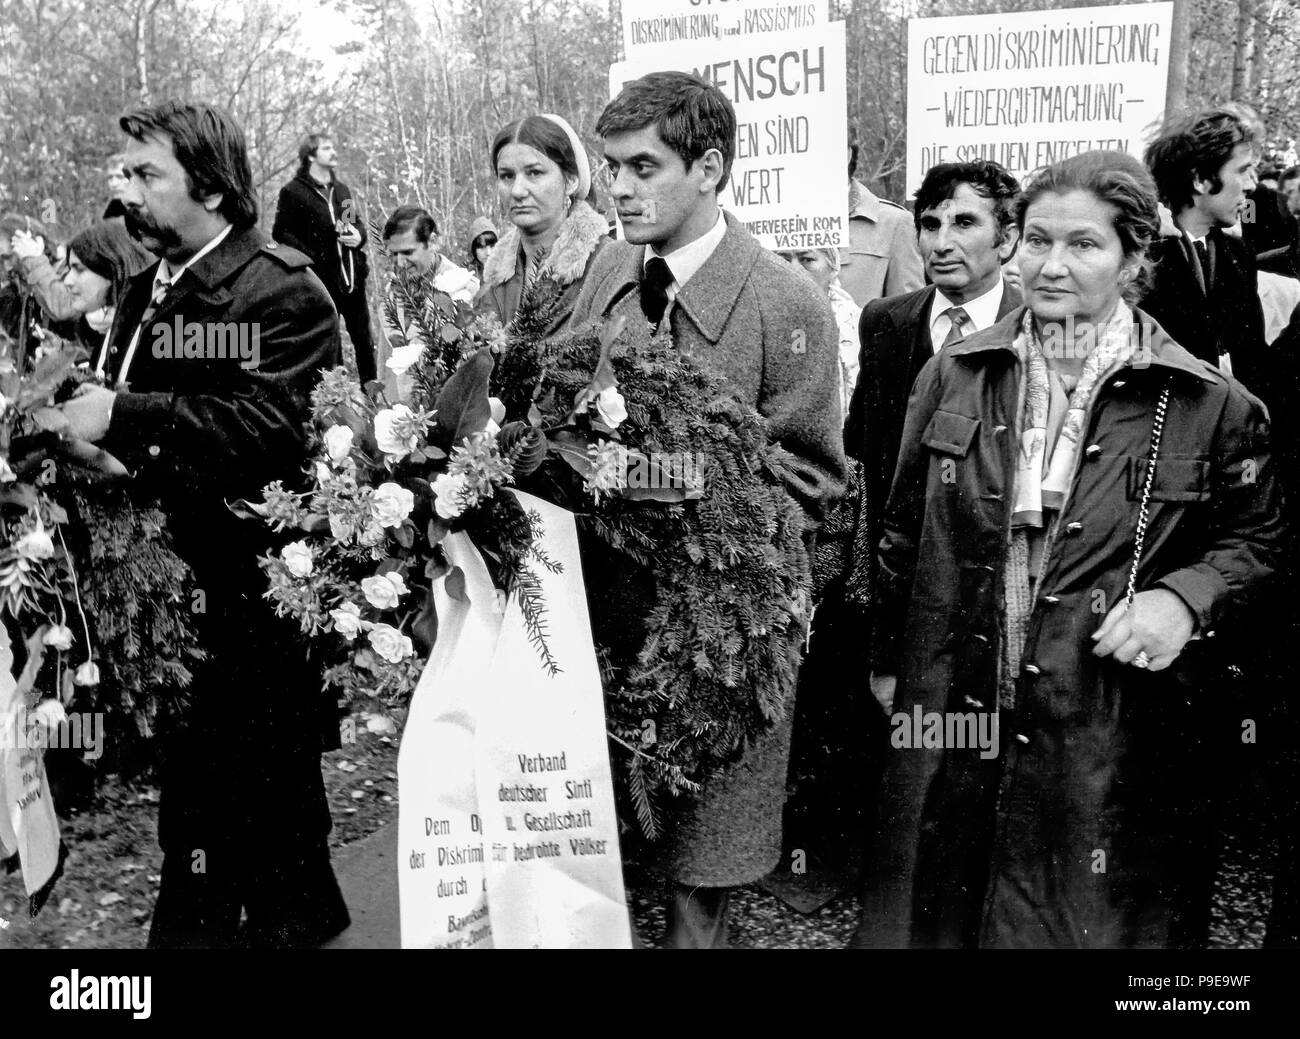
[1018,191,1134,324]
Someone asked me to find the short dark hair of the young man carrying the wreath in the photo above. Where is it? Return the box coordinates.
[595,72,736,192]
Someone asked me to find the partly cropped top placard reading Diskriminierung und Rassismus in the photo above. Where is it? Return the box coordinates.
[619,0,828,59]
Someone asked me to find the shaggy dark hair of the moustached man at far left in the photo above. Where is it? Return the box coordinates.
[118,101,257,228]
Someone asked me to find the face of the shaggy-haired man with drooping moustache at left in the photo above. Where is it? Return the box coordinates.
[122,134,221,260]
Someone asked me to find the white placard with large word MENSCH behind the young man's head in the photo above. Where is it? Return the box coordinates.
[610,22,849,250]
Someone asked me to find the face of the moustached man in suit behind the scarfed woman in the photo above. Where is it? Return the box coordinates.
[918,183,1015,303]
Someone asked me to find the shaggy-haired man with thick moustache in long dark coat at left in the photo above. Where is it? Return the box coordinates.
[64,103,348,948]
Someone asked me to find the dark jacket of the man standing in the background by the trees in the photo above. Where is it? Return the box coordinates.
[270,169,369,299]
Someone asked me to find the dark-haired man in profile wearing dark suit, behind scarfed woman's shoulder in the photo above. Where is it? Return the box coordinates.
[1141,109,1268,394]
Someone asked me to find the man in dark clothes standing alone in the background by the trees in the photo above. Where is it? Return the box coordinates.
[270,134,378,386]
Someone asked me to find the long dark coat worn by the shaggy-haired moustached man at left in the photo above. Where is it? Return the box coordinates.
[103,228,339,857]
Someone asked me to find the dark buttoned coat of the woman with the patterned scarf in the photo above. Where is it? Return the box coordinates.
[859,308,1281,947]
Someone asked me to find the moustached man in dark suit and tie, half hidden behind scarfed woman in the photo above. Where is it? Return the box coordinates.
[844,161,1021,697]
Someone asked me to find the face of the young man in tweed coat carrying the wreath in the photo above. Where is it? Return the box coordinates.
[605,126,722,254]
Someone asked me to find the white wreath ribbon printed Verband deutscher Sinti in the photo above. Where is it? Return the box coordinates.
[398,492,631,948]
